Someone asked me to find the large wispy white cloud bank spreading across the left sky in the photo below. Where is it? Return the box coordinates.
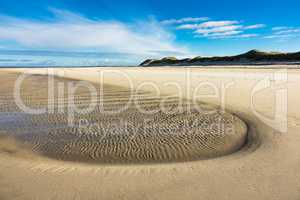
[0,9,187,54]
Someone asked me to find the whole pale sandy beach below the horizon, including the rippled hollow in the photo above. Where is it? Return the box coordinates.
[0,66,300,200]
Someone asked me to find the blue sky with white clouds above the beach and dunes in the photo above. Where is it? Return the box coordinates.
[0,0,300,66]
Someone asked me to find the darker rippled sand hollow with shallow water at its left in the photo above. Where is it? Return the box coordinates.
[0,73,247,163]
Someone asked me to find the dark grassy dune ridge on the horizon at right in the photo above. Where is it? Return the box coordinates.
[140,50,300,66]
